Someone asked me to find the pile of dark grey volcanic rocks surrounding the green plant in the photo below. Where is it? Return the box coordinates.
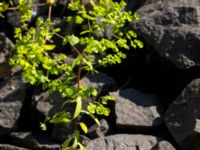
[0,0,200,150]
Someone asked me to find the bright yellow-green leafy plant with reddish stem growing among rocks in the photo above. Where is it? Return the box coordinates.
[0,0,143,150]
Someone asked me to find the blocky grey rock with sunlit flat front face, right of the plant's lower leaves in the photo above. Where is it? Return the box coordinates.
[110,89,164,129]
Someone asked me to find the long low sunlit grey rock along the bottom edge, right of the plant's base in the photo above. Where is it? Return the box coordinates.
[86,134,173,150]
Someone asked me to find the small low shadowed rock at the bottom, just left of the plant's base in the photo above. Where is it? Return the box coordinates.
[10,132,61,150]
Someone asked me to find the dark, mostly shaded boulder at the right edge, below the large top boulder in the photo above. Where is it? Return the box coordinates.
[165,79,200,150]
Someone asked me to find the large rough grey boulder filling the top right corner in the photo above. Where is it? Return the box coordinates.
[133,0,200,69]
